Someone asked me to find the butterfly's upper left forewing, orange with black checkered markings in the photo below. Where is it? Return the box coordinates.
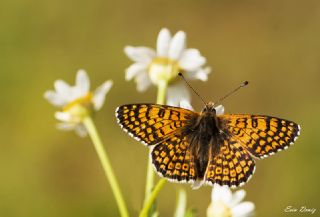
[116,104,196,145]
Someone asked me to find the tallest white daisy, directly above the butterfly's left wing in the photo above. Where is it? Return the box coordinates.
[124,28,210,106]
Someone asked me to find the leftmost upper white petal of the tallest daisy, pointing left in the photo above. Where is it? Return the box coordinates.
[124,46,156,63]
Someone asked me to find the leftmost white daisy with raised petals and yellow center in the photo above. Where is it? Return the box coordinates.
[44,70,112,136]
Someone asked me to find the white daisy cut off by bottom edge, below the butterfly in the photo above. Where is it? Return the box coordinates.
[207,185,254,217]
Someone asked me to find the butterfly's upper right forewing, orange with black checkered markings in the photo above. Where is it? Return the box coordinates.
[218,115,300,158]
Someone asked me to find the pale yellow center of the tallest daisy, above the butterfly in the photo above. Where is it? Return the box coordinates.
[148,57,180,85]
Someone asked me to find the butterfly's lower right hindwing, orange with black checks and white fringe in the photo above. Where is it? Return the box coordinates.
[205,135,255,187]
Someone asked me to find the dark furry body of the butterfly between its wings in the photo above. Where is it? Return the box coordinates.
[188,107,220,178]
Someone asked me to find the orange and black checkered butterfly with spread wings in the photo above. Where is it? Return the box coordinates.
[116,102,300,188]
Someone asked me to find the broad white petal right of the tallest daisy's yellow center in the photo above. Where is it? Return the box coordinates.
[179,49,206,71]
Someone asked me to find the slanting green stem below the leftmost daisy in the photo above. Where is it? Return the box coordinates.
[83,115,129,217]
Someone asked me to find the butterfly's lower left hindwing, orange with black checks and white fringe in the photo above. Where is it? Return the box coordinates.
[151,134,197,183]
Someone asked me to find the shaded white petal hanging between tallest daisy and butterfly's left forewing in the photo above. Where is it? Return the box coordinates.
[167,81,190,106]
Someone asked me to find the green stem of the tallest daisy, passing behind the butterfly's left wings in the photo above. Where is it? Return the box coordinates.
[144,81,168,215]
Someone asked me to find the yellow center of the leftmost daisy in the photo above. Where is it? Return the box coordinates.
[63,92,93,123]
